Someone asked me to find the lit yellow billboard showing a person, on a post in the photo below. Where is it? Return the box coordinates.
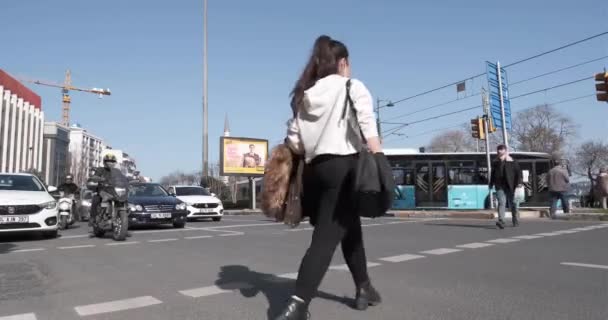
[220,137,268,177]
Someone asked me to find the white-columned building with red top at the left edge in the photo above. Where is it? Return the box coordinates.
[0,70,44,173]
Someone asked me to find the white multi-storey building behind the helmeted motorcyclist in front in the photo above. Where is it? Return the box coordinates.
[69,125,105,185]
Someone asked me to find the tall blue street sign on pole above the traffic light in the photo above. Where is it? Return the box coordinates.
[486,61,512,131]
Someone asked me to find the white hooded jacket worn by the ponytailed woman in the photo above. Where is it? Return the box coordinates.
[287,74,378,163]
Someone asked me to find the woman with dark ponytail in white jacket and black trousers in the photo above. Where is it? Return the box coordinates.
[276,36,382,320]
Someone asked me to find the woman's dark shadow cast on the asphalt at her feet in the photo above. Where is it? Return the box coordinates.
[215,265,354,319]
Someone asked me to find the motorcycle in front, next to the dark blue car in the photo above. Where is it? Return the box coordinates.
[87,174,129,241]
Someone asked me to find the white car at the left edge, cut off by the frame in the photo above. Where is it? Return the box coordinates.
[0,173,58,237]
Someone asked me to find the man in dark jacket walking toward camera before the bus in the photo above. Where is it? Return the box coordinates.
[489,144,523,229]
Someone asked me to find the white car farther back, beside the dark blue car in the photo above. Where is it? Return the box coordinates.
[169,186,224,221]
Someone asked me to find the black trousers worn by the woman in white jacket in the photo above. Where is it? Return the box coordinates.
[295,155,369,303]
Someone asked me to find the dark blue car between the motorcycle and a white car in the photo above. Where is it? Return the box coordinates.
[129,183,188,228]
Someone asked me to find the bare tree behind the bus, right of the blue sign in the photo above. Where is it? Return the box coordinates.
[512,104,577,156]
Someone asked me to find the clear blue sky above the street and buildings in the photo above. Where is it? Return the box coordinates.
[0,0,608,179]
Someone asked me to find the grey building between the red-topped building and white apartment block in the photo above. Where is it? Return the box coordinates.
[42,122,71,186]
